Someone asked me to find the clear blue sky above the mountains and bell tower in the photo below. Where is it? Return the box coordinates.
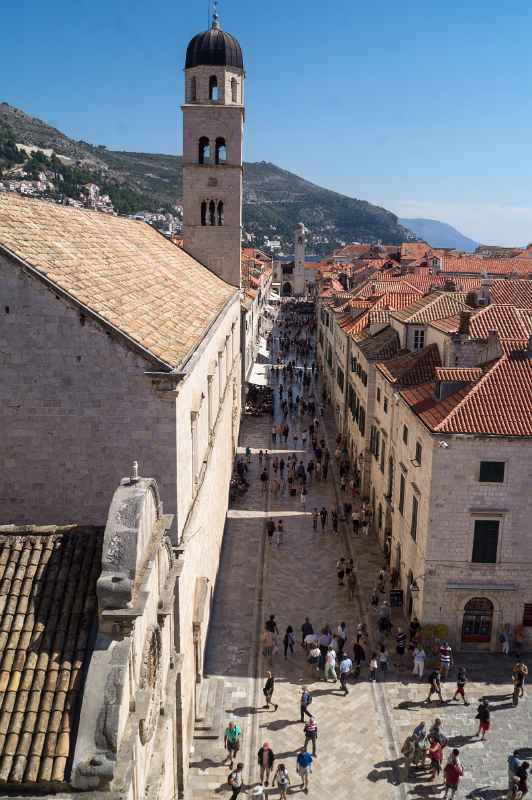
[0,0,532,245]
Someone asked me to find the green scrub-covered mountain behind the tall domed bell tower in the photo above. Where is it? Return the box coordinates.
[0,103,411,255]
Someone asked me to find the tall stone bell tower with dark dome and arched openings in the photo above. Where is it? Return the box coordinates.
[182,11,245,287]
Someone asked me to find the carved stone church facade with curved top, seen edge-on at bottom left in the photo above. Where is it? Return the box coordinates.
[71,476,178,800]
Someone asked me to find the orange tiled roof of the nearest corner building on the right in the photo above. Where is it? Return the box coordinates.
[401,350,532,437]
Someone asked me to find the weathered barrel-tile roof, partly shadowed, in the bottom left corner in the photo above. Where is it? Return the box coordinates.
[0,528,103,785]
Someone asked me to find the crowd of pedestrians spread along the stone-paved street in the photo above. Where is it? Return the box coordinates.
[224,302,529,800]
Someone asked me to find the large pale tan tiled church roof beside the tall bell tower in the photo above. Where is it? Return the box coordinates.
[0,193,237,368]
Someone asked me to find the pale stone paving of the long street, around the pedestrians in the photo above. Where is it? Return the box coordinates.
[191,306,532,800]
